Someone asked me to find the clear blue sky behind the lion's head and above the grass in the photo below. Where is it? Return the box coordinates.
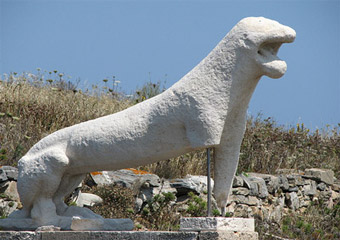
[0,0,340,129]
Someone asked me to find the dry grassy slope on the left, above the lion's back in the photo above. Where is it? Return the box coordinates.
[0,70,131,166]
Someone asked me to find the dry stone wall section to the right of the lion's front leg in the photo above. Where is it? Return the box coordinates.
[227,169,340,223]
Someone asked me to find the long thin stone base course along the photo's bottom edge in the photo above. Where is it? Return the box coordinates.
[0,231,258,240]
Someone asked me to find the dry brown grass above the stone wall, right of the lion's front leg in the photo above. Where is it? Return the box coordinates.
[239,117,340,177]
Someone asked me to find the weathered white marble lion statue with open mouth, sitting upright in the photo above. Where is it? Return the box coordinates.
[10,17,296,226]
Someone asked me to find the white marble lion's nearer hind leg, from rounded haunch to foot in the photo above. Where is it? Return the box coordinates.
[14,149,68,225]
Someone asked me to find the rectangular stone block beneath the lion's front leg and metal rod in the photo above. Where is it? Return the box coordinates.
[180,217,255,232]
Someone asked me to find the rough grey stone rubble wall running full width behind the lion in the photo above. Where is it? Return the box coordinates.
[0,167,340,227]
